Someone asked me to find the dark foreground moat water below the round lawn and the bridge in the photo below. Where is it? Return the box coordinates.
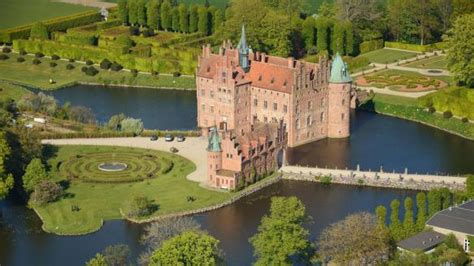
[0,181,415,266]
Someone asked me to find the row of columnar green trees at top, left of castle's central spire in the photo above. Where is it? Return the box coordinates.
[118,0,224,35]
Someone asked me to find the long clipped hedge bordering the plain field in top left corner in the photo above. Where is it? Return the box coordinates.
[0,10,102,42]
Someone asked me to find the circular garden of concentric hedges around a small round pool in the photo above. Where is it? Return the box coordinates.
[59,152,173,183]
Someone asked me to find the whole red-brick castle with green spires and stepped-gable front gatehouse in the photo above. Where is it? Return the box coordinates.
[196,26,352,189]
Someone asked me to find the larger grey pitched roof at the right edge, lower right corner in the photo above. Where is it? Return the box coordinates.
[426,200,474,235]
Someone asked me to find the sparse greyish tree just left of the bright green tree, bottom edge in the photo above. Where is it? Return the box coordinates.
[139,216,201,265]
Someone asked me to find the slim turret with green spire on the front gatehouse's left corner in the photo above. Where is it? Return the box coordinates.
[207,126,222,187]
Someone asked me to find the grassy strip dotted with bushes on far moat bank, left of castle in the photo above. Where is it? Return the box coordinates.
[0,53,196,90]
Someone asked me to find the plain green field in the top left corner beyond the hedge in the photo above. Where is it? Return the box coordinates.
[0,0,93,30]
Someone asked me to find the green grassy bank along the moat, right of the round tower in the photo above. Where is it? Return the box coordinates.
[359,94,474,140]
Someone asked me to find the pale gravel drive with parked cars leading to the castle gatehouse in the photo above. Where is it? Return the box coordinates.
[42,137,207,186]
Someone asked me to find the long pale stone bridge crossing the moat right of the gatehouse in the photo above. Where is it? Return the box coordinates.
[280,166,466,190]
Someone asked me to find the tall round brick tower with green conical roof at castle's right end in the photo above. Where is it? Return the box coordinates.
[328,53,352,138]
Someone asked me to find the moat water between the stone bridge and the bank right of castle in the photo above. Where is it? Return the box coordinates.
[287,112,474,174]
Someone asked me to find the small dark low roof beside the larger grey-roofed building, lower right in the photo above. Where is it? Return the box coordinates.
[397,230,446,251]
